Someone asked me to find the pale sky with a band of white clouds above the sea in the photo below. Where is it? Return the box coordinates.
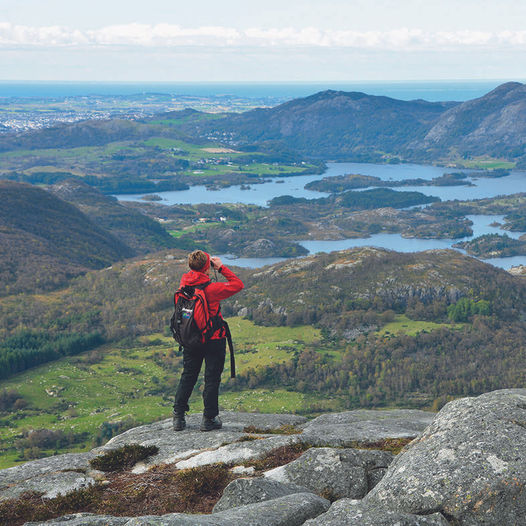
[0,0,526,82]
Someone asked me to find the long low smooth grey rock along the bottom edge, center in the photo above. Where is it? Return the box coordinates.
[126,493,330,526]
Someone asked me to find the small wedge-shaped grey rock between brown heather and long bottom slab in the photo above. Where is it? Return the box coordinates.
[214,477,310,513]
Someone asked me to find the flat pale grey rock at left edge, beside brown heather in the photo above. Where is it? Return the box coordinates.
[0,471,95,501]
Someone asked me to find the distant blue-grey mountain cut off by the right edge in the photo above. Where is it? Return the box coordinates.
[409,82,526,162]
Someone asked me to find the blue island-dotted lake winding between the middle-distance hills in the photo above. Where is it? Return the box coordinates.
[116,163,526,269]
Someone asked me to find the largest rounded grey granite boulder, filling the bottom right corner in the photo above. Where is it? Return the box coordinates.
[366,389,526,526]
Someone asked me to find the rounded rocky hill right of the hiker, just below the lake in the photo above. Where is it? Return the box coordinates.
[239,247,526,329]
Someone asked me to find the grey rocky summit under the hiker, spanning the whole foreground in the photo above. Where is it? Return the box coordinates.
[0,389,526,526]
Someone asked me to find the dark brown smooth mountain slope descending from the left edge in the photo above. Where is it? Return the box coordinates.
[0,181,134,296]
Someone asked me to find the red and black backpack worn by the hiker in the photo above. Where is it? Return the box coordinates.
[170,281,236,378]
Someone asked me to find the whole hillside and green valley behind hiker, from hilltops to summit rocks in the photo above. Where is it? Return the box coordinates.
[0,248,526,465]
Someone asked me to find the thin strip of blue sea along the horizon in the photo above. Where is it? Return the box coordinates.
[0,79,517,101]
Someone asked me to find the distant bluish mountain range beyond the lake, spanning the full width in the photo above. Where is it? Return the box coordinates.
[0,82,526,166]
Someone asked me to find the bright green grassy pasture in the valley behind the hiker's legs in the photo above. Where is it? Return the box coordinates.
[0,318,326,469]
